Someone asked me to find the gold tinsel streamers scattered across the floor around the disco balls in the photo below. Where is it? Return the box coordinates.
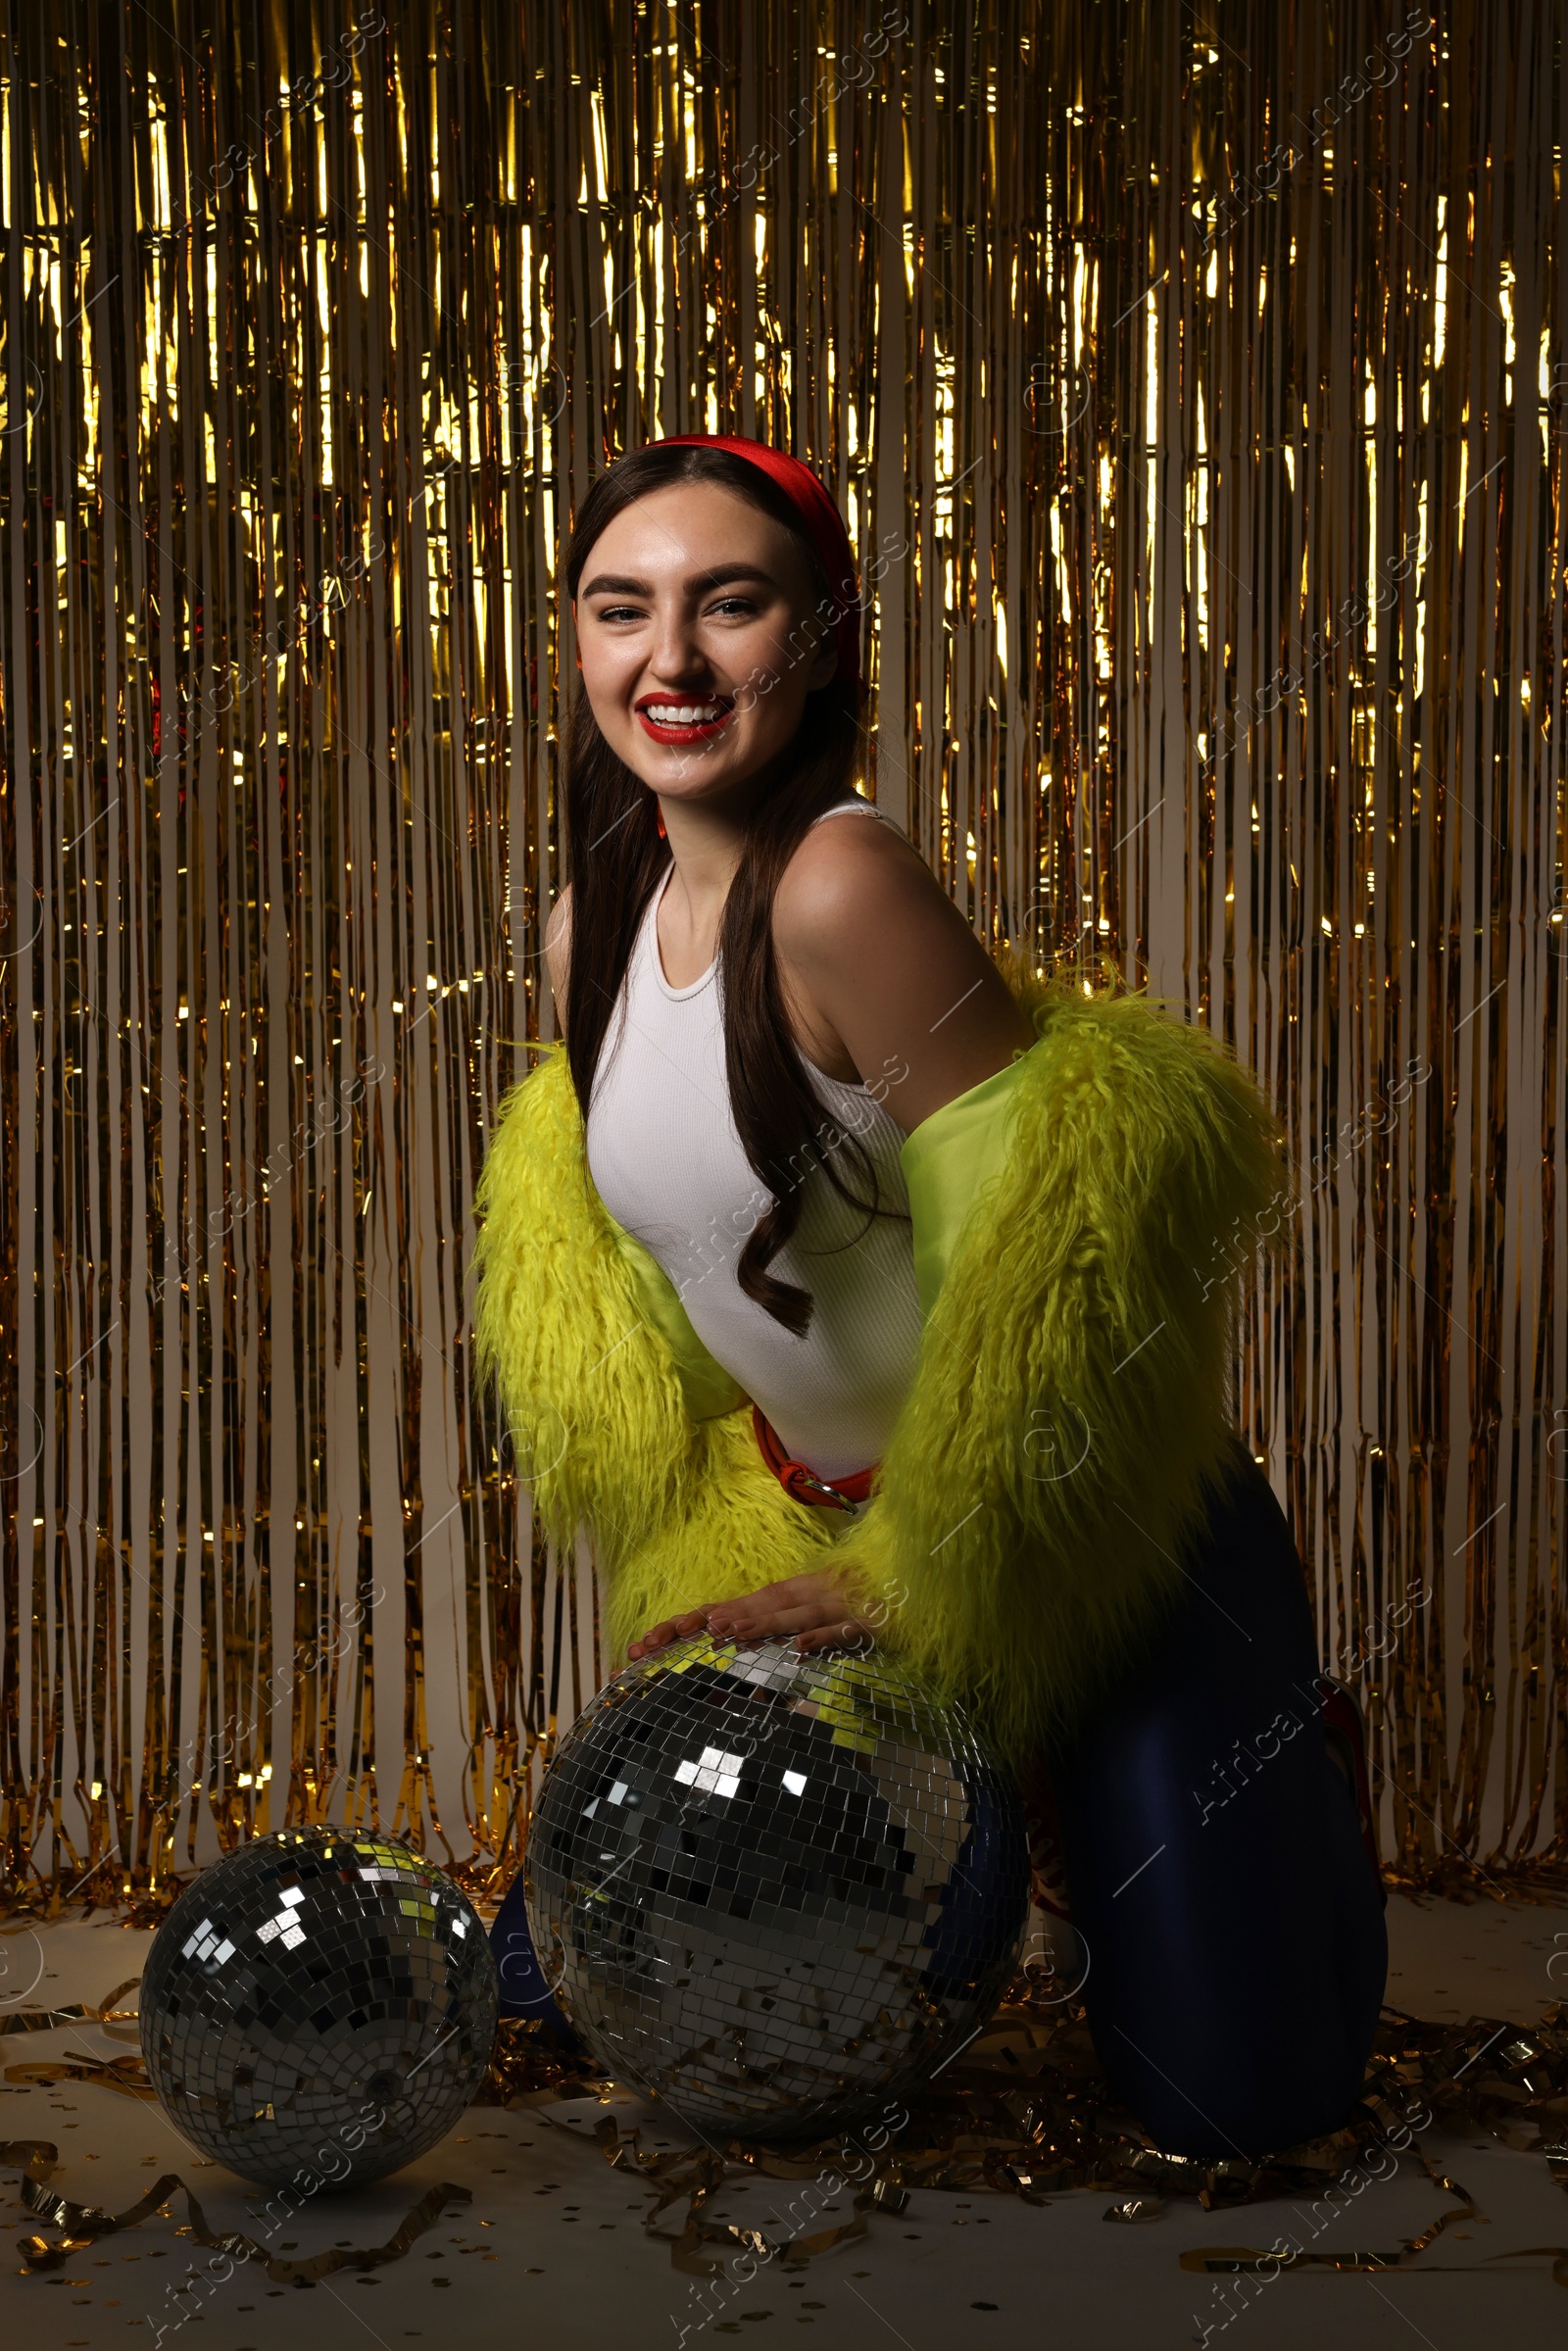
[0,1970,1568,2284]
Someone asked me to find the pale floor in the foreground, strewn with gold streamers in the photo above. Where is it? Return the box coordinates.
[0,1897,1568,2351]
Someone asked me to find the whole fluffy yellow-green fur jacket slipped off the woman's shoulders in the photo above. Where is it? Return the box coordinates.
[475,968,1281,1754]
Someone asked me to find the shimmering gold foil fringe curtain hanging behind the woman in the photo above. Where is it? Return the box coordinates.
[0,0,1568,1897]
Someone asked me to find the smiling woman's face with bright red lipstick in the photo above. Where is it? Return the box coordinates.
[573,482,837,800]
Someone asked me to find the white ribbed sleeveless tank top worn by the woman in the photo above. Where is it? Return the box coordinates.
[588,795,921,1481]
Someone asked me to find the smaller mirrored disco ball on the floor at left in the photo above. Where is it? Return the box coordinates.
[141,1829,501,2186]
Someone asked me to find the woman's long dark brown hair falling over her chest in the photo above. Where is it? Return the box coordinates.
[564,444,907,1338]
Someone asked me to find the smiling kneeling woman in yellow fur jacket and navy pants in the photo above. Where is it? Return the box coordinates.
[477,435,1387,2156]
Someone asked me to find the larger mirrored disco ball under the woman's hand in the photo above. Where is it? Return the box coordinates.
[524,1637,1030,2137]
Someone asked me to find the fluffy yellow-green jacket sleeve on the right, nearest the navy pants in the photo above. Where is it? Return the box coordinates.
[835,988,1281,1751]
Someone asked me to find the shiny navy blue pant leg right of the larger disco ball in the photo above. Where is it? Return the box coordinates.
[1049,1442,1387,2156]
